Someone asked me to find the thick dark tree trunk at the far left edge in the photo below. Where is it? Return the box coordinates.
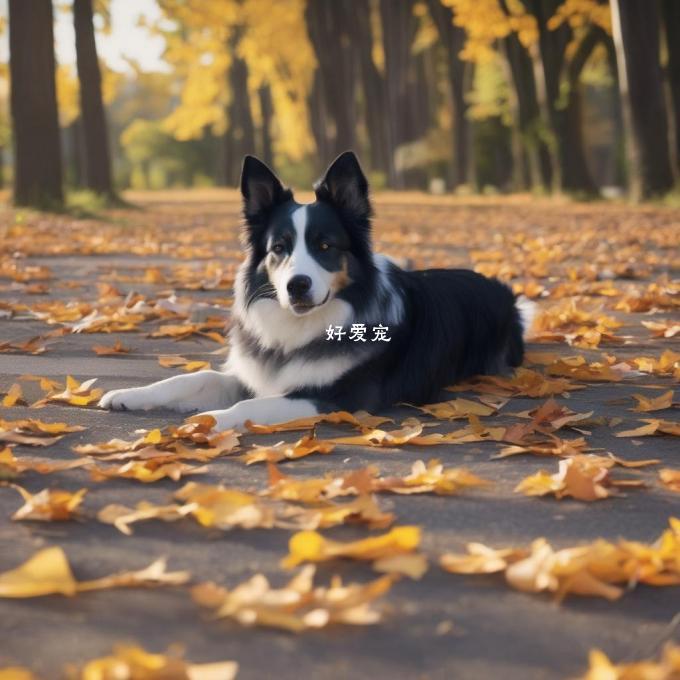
[9,0,64,208]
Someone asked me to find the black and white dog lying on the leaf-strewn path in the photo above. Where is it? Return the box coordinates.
[100,152,533,429]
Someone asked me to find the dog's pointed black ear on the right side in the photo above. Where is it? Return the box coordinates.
[314,151,372,221]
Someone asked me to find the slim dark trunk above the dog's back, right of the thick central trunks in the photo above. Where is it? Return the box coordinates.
[428,0,472,189]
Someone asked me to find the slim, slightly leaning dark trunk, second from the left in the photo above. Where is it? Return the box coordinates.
[73,0,114,196]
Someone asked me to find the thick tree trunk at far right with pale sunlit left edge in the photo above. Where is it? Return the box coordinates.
[611,0,673,200]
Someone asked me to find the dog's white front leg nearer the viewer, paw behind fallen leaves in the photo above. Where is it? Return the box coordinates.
[201,397,319,430]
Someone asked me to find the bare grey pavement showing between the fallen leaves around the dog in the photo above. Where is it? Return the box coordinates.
[0,193,680,680]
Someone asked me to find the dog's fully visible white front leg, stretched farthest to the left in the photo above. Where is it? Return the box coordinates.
[99,371,243,413]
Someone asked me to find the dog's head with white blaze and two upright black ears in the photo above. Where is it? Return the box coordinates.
[241,151,371,316]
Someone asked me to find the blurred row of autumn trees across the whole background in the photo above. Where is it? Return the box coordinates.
[0,0,680,205]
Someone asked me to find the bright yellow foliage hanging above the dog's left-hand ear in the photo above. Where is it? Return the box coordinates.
[160,0,315,160]
